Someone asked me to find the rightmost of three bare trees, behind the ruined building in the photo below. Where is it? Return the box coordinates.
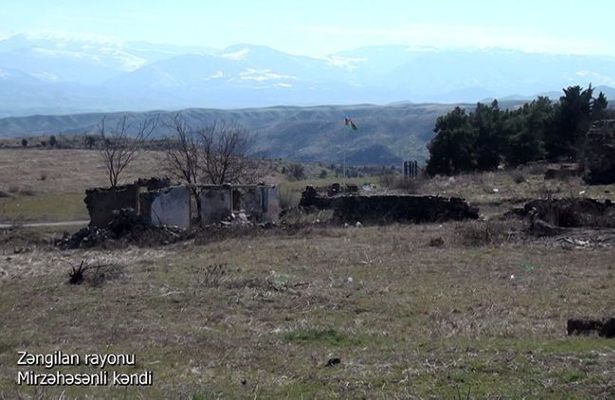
[198,122,257,185]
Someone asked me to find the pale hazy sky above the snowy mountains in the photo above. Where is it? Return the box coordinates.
[0,0,615,56]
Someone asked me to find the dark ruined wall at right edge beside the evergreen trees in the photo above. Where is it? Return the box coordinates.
[583,120,615,185]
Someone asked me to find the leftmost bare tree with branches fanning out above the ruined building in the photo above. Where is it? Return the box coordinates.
[100,116,158,188]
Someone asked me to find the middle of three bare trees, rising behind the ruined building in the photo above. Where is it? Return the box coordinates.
[165,114,203,220]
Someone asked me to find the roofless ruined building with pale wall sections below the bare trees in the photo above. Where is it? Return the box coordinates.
[84,179,280,229]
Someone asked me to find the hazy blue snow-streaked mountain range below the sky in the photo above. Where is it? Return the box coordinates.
[0,34,615,117]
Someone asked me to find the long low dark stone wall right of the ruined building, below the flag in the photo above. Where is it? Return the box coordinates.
[299,187,478,224]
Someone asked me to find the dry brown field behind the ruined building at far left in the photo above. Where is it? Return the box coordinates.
[0,149,165,223]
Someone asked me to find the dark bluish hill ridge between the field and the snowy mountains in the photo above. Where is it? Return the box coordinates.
[0,104,470,165]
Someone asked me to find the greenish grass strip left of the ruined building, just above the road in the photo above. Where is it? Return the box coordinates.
[0,193,88,222]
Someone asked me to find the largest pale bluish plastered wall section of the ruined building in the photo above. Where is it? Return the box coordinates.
[139,186,192,229]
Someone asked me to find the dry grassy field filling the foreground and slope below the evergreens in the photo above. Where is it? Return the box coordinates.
[0,148,615,399]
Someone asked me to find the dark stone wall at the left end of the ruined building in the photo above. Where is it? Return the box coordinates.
[84,184,144,227]
